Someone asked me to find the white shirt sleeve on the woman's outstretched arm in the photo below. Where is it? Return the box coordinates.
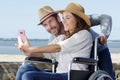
[58,30,92,53]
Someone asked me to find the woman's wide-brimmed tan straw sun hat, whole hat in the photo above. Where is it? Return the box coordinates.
[56,2,91,26]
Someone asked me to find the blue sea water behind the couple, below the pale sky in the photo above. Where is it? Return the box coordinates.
[0,38,120,55]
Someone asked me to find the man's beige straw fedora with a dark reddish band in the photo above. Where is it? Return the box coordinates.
[38,6,57,25]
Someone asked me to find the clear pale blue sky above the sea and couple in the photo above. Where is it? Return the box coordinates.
[0,0,120,40]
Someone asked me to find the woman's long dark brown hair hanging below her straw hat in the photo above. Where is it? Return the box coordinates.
[66,13,89,38]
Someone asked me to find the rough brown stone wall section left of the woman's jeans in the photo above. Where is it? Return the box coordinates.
[0,62,21,80]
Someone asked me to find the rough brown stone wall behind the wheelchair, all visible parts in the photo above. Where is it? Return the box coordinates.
[0,62,120,80]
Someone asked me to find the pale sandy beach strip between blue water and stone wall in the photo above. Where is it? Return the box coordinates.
[0,53,120,63]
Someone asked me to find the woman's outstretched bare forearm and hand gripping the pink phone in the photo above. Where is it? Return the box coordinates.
[17,37,61,57]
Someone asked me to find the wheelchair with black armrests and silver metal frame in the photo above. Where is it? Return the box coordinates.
[24,37,113,80]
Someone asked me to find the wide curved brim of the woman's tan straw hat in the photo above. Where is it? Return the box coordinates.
[55,10,91,27]
